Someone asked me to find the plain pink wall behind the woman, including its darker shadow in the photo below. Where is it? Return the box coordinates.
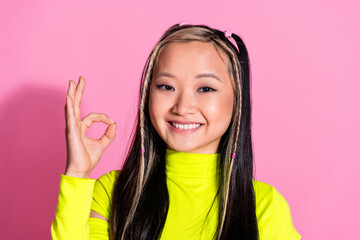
[0,0,360,239]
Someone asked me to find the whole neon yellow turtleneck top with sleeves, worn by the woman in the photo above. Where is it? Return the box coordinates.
[51,149,301,240]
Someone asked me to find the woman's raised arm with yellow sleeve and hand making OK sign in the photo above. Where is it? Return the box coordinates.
[51,77,116,240]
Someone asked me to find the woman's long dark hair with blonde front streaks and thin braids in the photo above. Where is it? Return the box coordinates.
[110,24,258,240]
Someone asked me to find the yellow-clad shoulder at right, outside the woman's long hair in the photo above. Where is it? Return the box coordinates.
[253,180,301,239]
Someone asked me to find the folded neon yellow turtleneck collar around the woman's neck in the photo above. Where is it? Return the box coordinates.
[166,149,220,179]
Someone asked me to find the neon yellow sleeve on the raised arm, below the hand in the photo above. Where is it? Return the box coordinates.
[51,174,109,240]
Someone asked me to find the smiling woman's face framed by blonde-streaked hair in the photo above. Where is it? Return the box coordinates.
[149,41,234,154]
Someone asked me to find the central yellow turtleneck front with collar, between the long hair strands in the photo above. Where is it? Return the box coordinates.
[161,149,220,240]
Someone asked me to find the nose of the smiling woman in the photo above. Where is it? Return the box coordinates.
[172,92,197,115]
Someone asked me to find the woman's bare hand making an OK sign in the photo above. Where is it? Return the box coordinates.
[64,76,116,178]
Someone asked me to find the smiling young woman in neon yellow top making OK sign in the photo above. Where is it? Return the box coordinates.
[51,23,301,240]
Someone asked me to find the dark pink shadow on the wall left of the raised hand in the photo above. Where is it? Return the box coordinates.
[0,81,66,239]
